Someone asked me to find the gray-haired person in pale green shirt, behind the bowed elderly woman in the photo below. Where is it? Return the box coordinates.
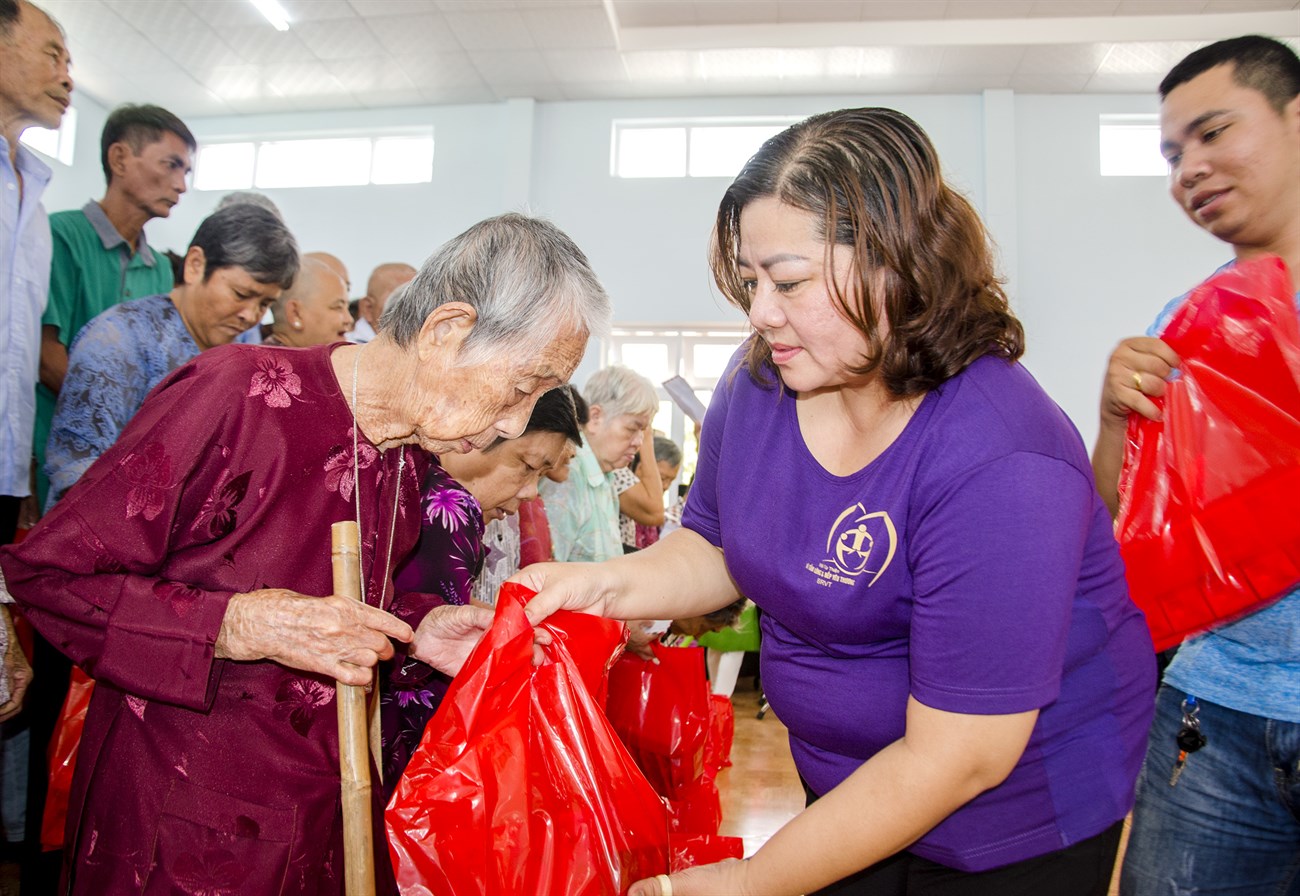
[542,365,662,560]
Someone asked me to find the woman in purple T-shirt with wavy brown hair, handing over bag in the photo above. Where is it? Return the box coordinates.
[520,109,1154,896]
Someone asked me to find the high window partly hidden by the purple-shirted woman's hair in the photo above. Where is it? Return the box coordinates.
[610,117,798,178]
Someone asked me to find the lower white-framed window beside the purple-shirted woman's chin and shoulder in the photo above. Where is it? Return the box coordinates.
[602,324,749,488]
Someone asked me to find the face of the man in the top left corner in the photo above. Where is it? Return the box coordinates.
[0,3,73,129]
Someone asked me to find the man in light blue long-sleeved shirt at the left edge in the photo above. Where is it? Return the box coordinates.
[0,0,73,719]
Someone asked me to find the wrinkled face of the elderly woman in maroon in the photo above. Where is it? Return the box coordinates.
[415,332,586,455]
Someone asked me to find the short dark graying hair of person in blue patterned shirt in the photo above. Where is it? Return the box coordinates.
[190,203,299,289]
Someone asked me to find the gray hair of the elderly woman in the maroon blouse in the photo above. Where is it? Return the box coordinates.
[378,213,612,364]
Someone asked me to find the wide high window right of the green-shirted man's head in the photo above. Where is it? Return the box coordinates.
[194,129,433,190]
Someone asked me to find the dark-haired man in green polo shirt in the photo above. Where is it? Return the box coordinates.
[34,105,196,510]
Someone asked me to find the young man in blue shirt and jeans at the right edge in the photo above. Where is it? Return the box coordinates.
[1092,36,1300,896]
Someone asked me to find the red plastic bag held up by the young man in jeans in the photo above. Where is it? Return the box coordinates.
[1115,257,1300,650]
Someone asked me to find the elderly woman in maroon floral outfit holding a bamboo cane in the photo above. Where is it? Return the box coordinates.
[0,215,610,896]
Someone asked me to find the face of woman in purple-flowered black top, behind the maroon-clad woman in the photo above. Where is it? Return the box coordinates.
[441,432,568,521]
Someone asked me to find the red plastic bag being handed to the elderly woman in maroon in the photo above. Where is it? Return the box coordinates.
[385,585,668,896]
